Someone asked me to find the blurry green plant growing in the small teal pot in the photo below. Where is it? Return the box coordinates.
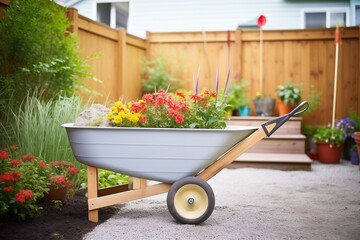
[226,80,250,109]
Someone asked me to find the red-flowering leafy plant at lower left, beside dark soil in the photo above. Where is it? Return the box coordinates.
[0,145,78,220]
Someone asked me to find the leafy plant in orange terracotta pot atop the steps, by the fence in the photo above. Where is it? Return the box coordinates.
[276,83,301,106]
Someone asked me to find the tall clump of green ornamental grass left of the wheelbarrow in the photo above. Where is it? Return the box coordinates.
[0,93,87,168]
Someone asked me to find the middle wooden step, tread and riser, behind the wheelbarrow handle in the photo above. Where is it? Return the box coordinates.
[247,134,306,154]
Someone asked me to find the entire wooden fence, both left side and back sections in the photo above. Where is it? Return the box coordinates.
[0,0,360,124]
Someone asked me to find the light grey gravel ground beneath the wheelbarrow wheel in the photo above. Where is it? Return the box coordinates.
[84,161,360,240]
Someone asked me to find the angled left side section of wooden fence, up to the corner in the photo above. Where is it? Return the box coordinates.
[68,8,147,103]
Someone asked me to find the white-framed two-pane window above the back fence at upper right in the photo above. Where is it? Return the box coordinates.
[302,9,349,28]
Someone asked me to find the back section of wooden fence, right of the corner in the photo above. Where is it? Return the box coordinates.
[147,27,360,124]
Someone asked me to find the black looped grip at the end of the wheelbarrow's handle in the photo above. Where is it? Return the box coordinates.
[261,101,309,137]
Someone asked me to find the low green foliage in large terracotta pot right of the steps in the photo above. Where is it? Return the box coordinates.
[314,127,345,145]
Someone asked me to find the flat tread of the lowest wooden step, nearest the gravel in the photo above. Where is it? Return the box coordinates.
[235,153,312,164]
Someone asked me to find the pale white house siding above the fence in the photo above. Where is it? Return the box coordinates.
[66,0,350,37]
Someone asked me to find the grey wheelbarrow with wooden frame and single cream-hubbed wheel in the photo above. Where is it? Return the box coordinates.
[62,101,309,224]
